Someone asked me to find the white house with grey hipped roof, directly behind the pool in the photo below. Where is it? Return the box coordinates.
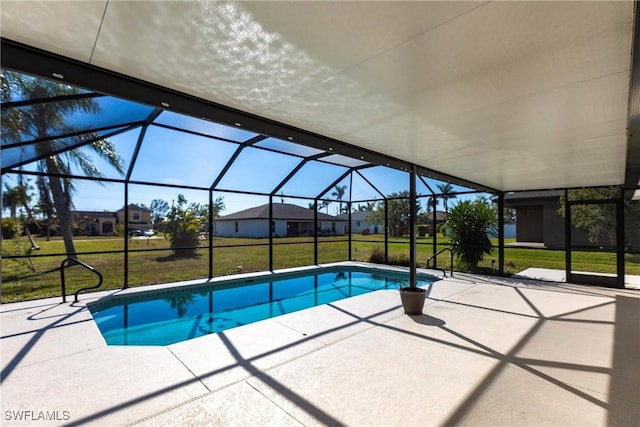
[214,203,347,238]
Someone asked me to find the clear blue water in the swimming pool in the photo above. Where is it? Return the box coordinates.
[88,267,437,345]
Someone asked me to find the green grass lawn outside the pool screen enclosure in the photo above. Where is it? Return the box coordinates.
[1,235,640,302]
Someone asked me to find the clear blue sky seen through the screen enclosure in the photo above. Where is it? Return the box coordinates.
[3,83,482,214]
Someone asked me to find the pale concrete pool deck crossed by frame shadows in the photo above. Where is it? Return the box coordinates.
[0,264,640,426]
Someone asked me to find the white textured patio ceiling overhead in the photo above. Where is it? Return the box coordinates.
[0,1,640,196]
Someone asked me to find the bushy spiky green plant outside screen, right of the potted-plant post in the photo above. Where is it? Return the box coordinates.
[445,200,497,270]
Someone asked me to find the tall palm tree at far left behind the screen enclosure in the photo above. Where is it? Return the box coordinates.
[0,70,124,256]
